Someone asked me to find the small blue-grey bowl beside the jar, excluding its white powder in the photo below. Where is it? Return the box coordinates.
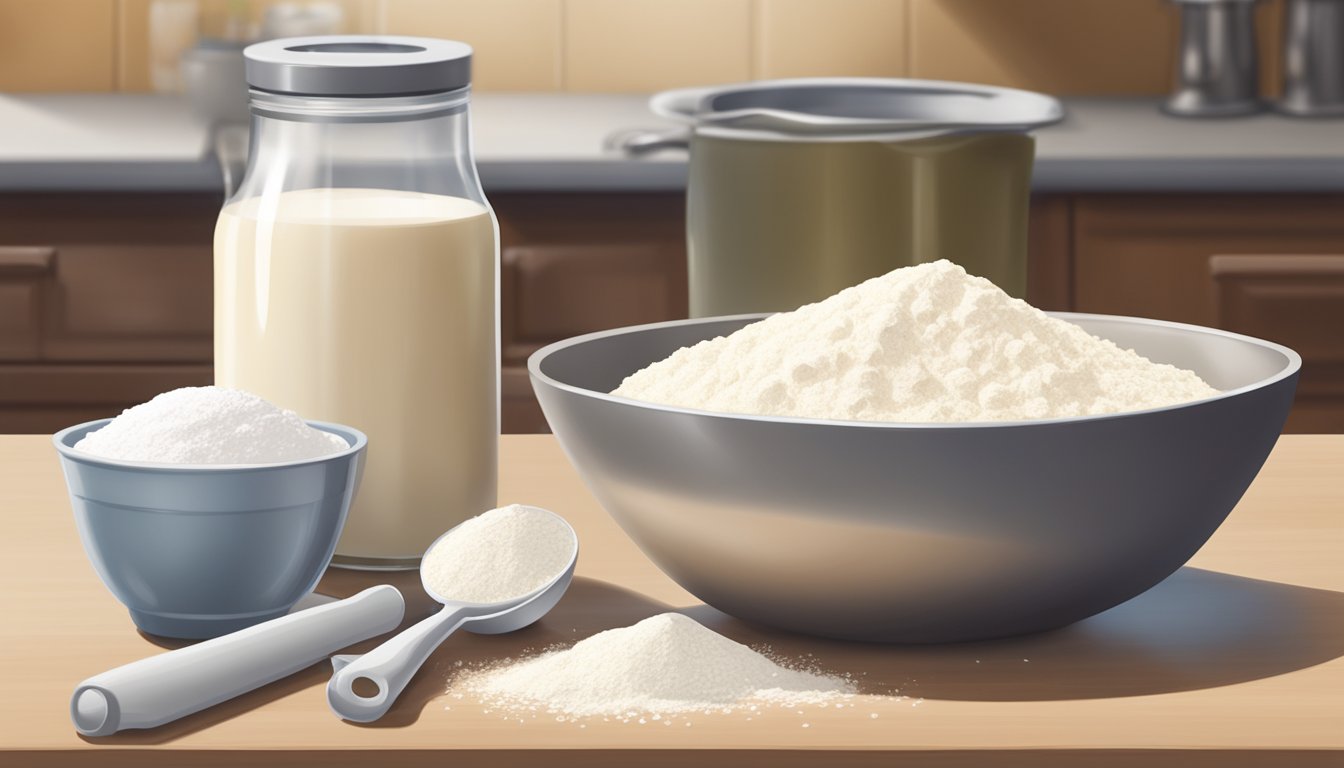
[52,418,368,639]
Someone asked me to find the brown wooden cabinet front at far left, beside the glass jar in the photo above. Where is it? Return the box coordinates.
[0,194,220,432]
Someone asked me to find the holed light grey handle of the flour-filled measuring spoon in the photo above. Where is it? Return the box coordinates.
[327,607,470,722]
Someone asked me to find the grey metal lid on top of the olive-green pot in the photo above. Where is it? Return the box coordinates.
[649,78,1064,141]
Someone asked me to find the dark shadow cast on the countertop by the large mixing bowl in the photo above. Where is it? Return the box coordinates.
[683,568,1344,701]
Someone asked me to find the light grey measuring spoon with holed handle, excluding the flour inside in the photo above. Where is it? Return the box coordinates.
[327,507,579,722]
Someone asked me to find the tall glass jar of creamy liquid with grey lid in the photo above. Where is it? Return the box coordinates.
[215,36,500,569]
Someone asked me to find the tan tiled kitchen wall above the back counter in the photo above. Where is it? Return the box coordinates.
[0,0,1281,95]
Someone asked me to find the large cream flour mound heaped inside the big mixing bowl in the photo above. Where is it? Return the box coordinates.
[612,261,1218,422]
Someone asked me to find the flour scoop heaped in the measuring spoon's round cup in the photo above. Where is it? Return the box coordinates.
[421,504,578,603]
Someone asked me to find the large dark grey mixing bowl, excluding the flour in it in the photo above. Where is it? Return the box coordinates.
[528,313,1301,643]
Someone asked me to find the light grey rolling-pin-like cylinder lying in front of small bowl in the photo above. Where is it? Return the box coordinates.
[70,584,406,736]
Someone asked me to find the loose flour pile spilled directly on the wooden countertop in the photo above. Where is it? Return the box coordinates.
[465,613,853,717]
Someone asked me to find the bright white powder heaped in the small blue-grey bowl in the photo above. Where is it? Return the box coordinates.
[74,386,349,464]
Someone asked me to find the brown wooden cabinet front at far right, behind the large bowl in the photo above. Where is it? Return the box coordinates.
[1074,195,1344,432]
